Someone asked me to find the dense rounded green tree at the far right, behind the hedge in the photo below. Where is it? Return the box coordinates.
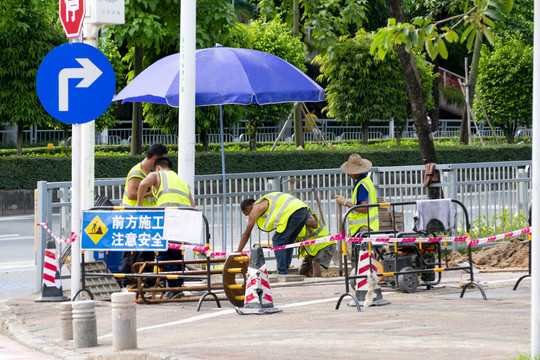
[473,36,533,143]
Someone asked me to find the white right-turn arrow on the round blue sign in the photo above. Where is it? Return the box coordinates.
[58,58,103,111]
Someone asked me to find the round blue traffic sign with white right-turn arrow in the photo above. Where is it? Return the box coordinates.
[36,43,116,124]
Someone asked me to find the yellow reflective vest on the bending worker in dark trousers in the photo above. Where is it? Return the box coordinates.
[255,192,309,233]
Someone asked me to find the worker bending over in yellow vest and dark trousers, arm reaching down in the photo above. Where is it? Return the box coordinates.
[237,192,315,274]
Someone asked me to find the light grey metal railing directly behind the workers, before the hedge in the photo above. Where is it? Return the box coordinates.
[37,161,531,251]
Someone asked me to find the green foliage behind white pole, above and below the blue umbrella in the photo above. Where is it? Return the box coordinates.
[115,0,242,150]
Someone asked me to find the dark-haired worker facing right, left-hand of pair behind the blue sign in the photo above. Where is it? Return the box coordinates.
[119,143,168,285]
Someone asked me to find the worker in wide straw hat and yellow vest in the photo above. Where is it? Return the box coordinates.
[335,154,379,236]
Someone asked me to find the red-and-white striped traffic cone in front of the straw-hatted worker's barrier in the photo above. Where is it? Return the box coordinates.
[356,250,390,306]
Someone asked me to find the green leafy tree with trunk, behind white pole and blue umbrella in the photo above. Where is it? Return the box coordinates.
[111,0,237,153]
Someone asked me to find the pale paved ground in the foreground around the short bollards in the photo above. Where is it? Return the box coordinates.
[0,271,531,360]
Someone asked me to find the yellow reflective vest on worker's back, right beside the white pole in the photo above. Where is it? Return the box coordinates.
[152,170,191,206]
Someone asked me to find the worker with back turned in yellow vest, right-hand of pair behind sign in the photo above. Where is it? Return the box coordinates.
[137,157,195,299]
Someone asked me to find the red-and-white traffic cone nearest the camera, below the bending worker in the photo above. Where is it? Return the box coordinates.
[235,246,281,315]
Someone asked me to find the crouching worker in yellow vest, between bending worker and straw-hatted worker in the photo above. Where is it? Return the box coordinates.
[296,213,336,277]
